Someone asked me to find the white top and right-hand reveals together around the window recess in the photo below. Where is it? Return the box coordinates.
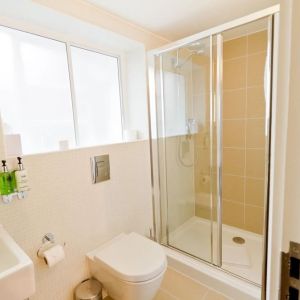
[0,0,154,139]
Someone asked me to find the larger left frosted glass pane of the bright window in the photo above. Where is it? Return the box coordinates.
[0,26,75,154]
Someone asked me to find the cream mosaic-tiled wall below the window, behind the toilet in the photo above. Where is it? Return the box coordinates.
[0,141,152,300]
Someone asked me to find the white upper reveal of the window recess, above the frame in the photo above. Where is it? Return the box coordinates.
[0,0,138,55]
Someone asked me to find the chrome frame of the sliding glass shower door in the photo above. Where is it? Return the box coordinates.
[148,5,280,298]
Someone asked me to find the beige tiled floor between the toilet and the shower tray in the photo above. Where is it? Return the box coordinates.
[154,268,229,300]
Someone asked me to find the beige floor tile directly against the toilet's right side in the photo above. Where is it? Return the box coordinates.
[161,268,208,300]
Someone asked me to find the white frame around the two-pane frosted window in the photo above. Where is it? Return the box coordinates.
[0,17,126,155]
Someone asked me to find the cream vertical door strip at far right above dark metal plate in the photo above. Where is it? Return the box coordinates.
[283,0,300,251]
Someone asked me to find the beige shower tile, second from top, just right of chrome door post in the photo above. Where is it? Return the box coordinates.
[223,57,246,90]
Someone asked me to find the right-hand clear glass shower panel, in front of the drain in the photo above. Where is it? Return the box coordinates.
[222,18,271,284]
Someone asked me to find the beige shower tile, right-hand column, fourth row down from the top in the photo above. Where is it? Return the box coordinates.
[246,119,266,148]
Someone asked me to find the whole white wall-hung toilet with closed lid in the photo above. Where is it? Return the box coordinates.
[87,232,167,300]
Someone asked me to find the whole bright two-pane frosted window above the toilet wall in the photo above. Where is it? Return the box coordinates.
[0,26,122,154]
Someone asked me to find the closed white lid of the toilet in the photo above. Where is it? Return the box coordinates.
[94,232,167,282]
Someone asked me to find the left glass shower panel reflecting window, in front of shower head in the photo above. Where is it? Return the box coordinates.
[155,37,215,262]
